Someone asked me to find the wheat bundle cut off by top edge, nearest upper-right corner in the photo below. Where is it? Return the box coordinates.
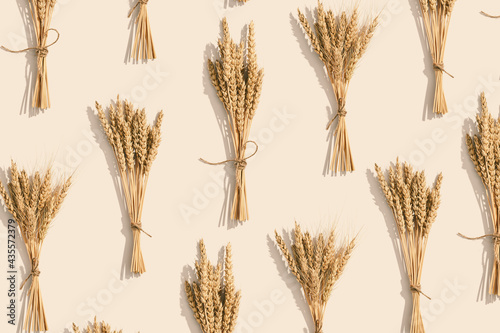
[418,0,456,114]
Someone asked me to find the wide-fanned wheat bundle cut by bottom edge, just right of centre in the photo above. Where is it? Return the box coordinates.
[274,223,356,333]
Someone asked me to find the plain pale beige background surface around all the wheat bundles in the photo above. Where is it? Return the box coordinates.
[0,0,500,333]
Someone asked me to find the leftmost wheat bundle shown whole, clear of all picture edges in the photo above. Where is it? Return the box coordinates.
[96,97,163,274]
